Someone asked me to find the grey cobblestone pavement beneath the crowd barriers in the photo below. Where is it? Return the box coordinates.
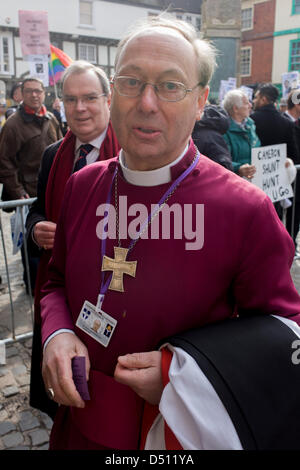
[0,212,300,450]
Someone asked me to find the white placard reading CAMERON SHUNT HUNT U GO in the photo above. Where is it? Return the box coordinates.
[252,144,293,202]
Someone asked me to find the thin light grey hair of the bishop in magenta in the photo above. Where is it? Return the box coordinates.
[115,14,217,87]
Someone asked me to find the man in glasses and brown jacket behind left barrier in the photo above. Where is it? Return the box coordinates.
[0,78,62,292]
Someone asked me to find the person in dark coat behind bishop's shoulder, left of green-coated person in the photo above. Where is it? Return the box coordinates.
[192,105,233,171]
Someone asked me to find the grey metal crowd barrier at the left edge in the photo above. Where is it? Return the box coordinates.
[0,198,36,345]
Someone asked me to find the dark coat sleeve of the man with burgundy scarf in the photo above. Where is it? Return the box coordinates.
[26,139,63,256]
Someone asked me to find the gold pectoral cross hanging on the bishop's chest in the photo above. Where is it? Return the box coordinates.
[101,246,137,292]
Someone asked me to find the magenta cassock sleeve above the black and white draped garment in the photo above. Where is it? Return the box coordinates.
[234,197,300,325]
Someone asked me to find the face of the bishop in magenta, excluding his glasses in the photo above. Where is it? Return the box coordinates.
[111,28,208,170]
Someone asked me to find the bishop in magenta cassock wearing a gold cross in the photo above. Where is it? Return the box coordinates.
[41,19,300,449]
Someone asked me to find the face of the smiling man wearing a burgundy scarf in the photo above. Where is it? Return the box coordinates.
[63,70,109,142]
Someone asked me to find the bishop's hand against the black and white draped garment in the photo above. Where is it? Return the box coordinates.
[114,351,163,405]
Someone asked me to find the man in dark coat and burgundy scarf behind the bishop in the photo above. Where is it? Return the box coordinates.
[26,61,119,417]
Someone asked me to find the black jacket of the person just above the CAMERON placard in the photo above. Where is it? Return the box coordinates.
[251,104,300,164]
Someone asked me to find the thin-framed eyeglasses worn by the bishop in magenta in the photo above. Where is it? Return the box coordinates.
[111,76,200,101]
